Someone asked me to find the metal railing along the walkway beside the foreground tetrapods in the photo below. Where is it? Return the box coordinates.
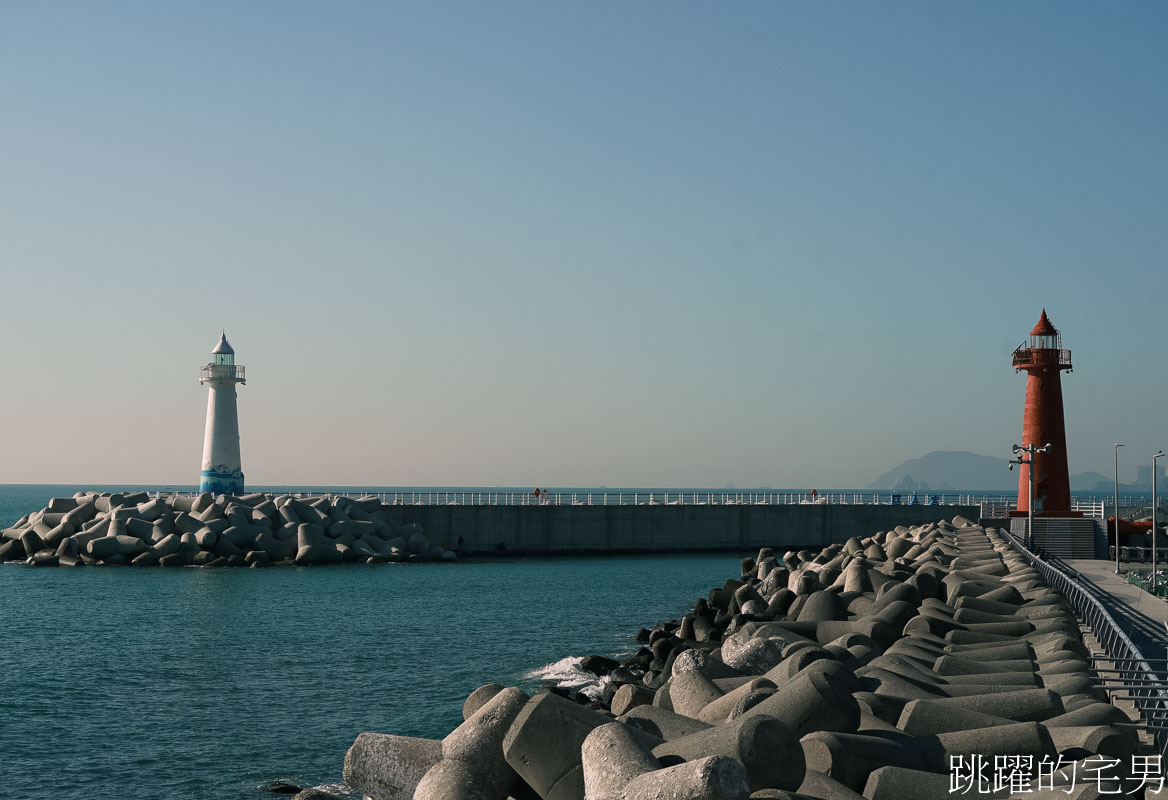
[1003,531,1168,757]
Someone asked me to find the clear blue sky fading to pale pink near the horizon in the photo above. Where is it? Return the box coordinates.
[0,0,1168,488]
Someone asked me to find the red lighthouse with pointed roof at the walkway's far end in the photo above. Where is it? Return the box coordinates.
[1014,308,1077,516]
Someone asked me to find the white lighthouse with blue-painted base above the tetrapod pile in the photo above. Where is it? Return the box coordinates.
[199,332,246,494]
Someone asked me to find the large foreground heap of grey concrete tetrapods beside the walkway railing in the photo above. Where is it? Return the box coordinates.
[334,516,1154,800]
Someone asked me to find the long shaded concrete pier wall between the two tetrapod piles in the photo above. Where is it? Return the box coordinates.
[387,505,980,555]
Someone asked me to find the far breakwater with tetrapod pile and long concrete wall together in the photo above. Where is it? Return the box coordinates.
[0,492,979,566]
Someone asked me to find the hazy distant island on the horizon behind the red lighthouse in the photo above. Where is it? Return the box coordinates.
[868,450,1122,492]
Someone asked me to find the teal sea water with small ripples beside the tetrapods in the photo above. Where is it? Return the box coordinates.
[0,487,739,800]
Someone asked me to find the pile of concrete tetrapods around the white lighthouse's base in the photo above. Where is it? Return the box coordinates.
[0,492,458,566]
